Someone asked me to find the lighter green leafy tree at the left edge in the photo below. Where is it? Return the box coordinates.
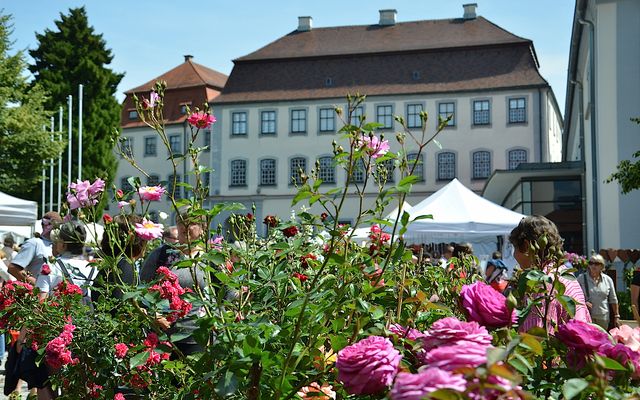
[0,11,64,200]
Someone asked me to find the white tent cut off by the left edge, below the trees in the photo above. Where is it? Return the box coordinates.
[0,192,38,241]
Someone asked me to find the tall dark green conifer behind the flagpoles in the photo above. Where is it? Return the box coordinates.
[29,7,124,198]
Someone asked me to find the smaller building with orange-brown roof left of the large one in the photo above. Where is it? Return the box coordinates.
[115,56,227,222]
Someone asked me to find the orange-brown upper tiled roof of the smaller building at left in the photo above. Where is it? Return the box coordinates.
[125,59,227,94]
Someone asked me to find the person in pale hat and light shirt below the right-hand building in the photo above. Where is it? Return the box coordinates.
[578,254,620,331]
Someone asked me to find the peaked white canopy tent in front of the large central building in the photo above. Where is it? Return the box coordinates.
[404,179,524,265]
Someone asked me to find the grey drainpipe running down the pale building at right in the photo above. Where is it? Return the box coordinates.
[578,18,600,252]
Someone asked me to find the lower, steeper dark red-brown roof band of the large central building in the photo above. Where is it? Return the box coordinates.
[213,43,548,104]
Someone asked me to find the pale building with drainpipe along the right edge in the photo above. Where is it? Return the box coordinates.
[564,0,640,251]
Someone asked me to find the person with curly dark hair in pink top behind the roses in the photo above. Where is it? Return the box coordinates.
[509,215,591,333]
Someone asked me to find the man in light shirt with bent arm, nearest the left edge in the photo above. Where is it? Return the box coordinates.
[8,211,62,285]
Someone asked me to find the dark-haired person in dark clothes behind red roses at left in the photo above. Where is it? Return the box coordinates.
[95,214,147,299]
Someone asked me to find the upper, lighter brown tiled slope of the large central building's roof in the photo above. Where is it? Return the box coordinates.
[235,17,530,62]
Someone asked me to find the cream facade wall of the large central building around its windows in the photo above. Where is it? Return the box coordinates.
[211,88,561,230]
